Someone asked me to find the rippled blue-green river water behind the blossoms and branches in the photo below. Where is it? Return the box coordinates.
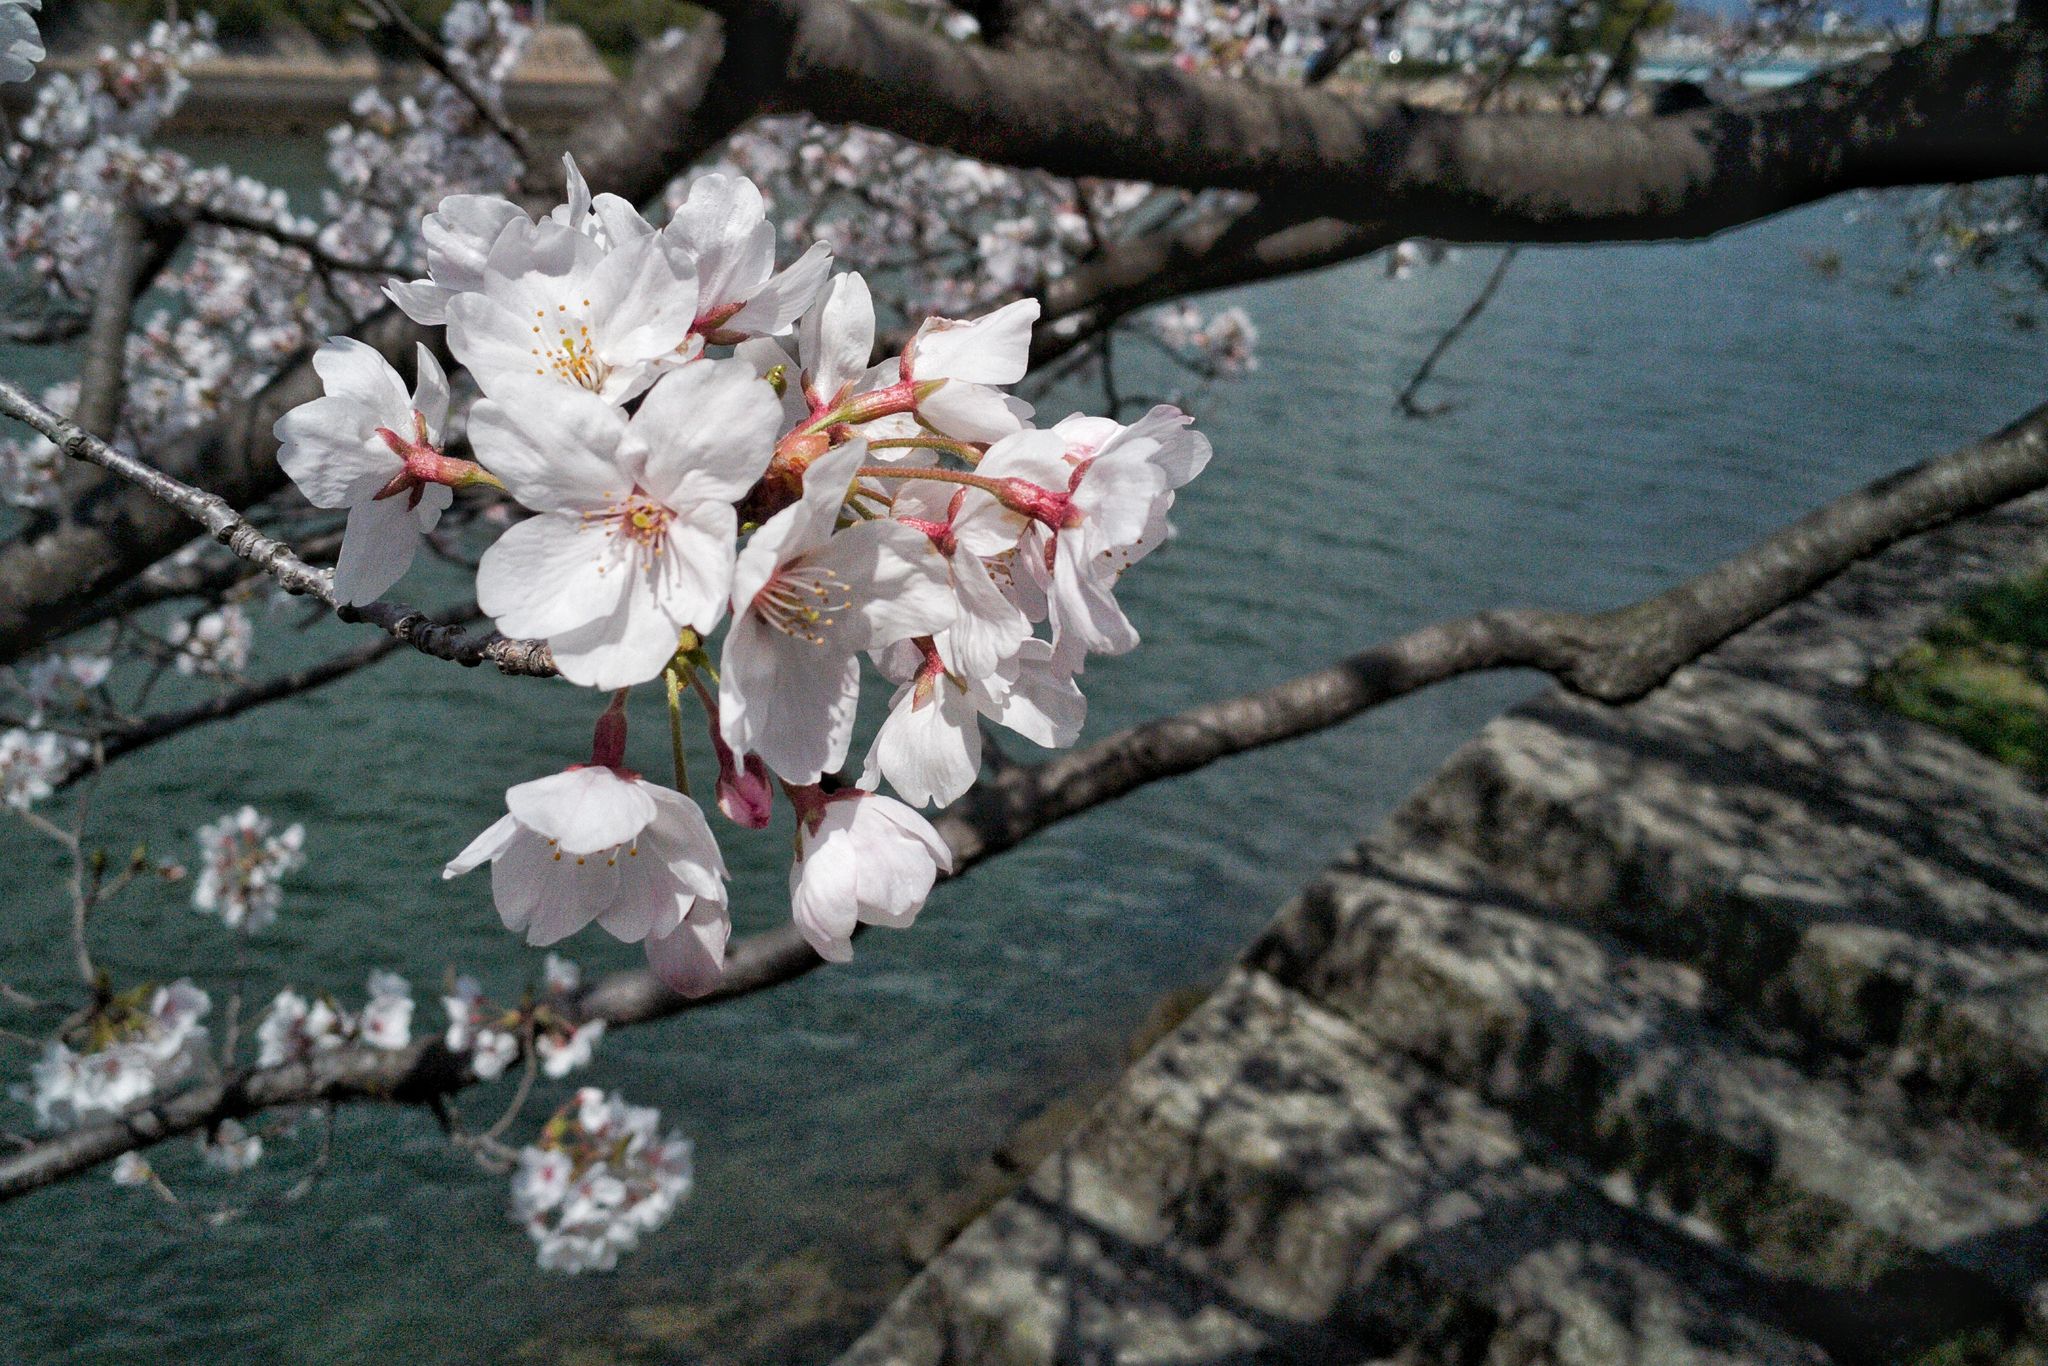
[0,141,2044,1362]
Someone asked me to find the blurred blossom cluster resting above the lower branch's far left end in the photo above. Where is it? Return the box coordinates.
[12,979,213,1128]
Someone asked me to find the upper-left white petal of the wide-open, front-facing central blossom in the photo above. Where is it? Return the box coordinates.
[469,383,637,512]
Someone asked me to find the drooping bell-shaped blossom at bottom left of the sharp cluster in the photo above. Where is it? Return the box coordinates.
[442,766,731,991]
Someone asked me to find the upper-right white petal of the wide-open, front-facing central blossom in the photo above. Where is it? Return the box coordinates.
[633,358,782,508]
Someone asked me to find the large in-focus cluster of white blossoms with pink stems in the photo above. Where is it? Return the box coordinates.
[276,164,1208,993]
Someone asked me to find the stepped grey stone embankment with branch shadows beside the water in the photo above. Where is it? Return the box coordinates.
[842,498,2048,1366]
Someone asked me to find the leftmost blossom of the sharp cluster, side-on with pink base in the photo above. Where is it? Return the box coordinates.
[274,336,455,606]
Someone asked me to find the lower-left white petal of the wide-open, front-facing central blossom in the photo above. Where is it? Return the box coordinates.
[477,512,633,637]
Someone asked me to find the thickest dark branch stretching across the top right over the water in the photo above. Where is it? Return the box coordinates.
[711,0,2048,232]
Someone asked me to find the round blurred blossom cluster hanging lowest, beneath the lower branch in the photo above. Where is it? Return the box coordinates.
[512,1085,690,1272]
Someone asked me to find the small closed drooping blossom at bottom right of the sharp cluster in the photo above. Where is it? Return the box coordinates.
[788,788,952,963]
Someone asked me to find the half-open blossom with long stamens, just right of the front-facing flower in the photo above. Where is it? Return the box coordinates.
[719,438,954,784]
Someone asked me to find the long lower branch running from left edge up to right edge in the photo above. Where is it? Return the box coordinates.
[0,405,2048,1200]
